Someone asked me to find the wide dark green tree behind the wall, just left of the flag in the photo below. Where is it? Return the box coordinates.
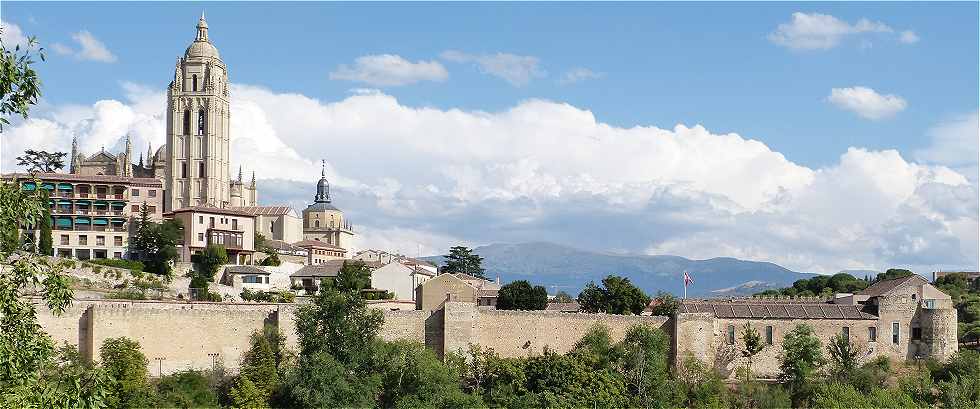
[578,276,650,315]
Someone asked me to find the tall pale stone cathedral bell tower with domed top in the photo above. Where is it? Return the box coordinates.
[164,13,230,211]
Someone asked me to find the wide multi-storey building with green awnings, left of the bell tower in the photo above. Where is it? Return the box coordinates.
[3,173,164,260]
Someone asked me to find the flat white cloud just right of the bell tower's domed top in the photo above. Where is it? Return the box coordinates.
[330,54,449,87]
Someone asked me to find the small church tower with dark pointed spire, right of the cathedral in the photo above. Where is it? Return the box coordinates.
[303,161,354,254]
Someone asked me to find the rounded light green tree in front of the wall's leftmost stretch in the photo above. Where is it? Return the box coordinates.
[99,337,149,408]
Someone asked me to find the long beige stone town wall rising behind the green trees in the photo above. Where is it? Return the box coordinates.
[37,300,672,376]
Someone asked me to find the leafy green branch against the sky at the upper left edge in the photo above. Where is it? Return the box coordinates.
[0,28,44,132]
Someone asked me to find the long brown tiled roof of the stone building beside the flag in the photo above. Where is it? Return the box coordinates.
[680,300,878,320]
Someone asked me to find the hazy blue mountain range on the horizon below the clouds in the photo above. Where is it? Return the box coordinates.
[424,242,815,297]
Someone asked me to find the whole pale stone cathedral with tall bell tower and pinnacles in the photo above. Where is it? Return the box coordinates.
[69,14,258,211]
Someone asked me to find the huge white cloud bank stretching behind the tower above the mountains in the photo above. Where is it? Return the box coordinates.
[0,84,980,272]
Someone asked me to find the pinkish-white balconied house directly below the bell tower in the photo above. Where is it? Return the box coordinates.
[164,206,255,264]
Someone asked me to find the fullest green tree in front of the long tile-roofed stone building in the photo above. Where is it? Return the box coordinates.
[779,324,825,406]
